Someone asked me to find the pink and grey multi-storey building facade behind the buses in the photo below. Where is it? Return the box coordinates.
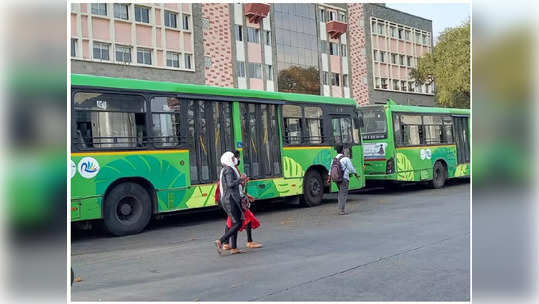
[71,3,434,105]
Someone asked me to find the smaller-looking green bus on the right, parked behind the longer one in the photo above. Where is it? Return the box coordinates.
[360,99,470,188]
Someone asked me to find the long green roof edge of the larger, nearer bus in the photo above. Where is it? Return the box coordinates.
[71,74,356,106]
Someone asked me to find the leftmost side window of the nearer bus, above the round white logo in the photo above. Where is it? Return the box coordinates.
[73,92,147,149]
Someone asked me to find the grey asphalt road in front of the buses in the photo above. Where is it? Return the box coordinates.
[71,181,470,301]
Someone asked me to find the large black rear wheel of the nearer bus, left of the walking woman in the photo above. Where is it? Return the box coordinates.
[104,182,152,236]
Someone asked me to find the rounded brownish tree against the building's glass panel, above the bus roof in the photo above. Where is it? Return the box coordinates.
[278,66,320,95]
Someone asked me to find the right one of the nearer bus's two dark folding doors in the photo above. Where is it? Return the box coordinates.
[240,103,281,179]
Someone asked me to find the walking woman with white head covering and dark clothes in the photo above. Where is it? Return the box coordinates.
[215,152,249,254]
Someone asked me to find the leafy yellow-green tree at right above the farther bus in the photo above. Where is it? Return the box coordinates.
[410,20,470,108]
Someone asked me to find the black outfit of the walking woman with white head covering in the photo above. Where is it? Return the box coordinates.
[219,167,244,249]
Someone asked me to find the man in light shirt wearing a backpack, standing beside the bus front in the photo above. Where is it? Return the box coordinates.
[327,144,358,215]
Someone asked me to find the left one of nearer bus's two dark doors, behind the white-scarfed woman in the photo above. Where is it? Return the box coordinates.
[186,100,234,185]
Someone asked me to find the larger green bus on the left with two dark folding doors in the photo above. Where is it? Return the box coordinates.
[71,74,365,235]
